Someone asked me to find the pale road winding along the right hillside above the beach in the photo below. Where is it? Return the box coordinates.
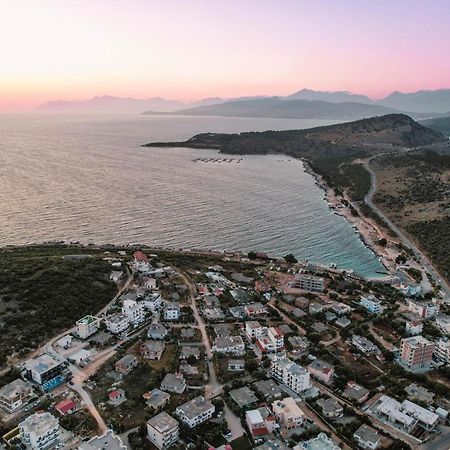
[362,155,450,299]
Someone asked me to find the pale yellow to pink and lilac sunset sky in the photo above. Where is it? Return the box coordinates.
[0,0,450,111]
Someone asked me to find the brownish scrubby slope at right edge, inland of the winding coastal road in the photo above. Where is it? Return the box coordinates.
[374,151,450,278]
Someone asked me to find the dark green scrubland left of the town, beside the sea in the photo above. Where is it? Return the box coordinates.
[0,246,116,365]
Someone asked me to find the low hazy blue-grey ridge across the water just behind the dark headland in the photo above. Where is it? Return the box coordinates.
[143,97,398,120]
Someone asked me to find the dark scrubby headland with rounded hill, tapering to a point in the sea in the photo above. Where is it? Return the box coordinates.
[144,114,445,158]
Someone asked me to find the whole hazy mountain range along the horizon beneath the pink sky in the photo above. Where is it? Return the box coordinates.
[36,89,450,120]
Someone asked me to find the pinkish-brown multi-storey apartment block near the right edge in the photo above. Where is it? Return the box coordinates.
[400,336,435,372]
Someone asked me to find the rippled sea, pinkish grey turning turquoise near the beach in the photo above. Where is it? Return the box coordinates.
[0,114,382,276]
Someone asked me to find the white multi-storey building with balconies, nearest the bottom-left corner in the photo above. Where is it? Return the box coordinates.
[19,412,60,450]
